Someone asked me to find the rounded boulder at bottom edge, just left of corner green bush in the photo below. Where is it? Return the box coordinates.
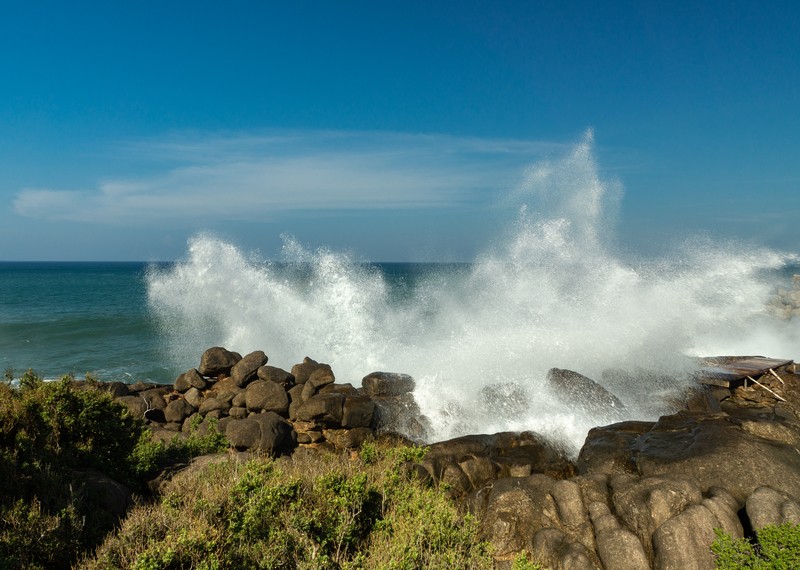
[653,505,717,570]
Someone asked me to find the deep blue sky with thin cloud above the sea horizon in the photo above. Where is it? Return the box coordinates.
[0,0,800,261]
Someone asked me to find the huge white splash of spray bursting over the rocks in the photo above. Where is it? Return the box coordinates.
[148,136,800,453]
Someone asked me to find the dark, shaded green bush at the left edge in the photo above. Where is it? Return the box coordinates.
[0,370,227,570]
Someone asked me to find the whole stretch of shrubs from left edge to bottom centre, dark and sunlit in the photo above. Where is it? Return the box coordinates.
[0,371,496,570]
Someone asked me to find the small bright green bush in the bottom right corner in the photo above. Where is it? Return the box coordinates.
[711,523,800,570]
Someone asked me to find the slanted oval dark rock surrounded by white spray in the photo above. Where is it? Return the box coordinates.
[547,368,625,421]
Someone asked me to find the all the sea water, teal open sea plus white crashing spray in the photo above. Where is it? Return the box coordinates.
[0,135,800,452]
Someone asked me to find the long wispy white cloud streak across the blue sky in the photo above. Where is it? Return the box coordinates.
[14,131,563,224]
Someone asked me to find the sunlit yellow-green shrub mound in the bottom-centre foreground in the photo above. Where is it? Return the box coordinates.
[84,438,493,570]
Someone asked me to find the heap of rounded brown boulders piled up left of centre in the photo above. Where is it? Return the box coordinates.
[113,347,424,454]
